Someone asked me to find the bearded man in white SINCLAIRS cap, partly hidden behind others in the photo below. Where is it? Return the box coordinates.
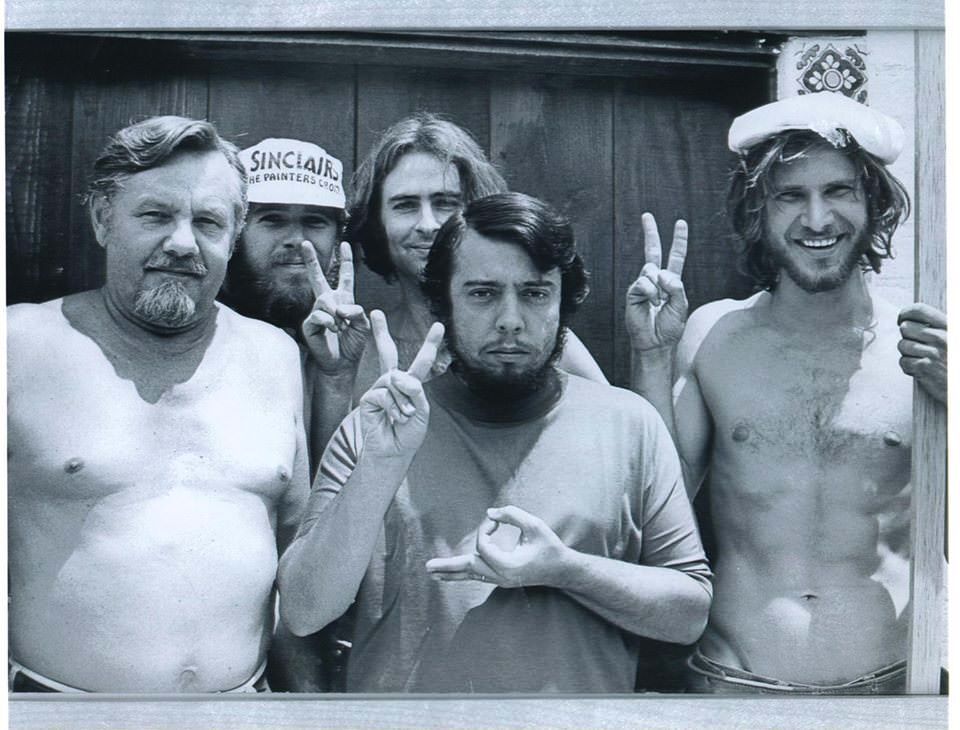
[220,138,369,691]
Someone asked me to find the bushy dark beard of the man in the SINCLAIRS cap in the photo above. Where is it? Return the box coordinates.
[227,249,340,329]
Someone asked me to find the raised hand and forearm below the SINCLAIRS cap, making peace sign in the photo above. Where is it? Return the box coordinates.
[301,241,370,466]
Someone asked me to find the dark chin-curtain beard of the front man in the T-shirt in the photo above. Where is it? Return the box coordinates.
[446,322,566,405]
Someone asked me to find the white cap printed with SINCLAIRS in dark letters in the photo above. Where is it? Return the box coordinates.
[240,137,346,209]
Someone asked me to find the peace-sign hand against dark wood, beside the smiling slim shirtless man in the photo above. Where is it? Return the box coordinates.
[626,213,687,350]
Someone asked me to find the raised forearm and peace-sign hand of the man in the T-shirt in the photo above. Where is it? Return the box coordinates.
[279,311,443,636]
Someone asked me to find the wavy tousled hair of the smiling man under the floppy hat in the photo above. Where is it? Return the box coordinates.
[727,130,910,289]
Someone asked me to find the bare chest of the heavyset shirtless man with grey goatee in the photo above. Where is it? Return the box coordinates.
[9,358,296,498]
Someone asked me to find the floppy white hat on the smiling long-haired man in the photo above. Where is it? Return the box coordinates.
[727,91,903,165]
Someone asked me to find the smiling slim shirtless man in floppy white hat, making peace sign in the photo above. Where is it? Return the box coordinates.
[627,93,946,693]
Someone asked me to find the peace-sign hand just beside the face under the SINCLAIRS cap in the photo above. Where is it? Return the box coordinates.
[300,241,370,375]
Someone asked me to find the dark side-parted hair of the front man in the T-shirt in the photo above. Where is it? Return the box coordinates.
[421,193,590,328]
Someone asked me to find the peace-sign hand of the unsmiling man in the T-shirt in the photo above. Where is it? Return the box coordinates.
[359,310,443,456]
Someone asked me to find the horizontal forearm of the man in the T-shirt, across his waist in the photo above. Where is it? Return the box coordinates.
[554,548,711,644]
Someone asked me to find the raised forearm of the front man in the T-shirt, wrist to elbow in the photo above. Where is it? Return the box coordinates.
[278,453,413,636]
